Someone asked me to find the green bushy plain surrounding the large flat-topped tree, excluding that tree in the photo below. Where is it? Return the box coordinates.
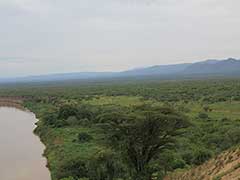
[0,79,240,180]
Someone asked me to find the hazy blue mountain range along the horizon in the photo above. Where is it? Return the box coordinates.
[0,58,240,83]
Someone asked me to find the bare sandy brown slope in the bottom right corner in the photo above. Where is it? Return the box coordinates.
[164,148,240,180]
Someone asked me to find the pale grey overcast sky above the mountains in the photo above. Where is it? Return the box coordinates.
[0,0,240,78]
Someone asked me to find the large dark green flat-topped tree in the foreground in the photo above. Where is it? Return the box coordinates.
[107,108,188,180]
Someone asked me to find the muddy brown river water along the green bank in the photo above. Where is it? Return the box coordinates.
[0,107,51,180]
